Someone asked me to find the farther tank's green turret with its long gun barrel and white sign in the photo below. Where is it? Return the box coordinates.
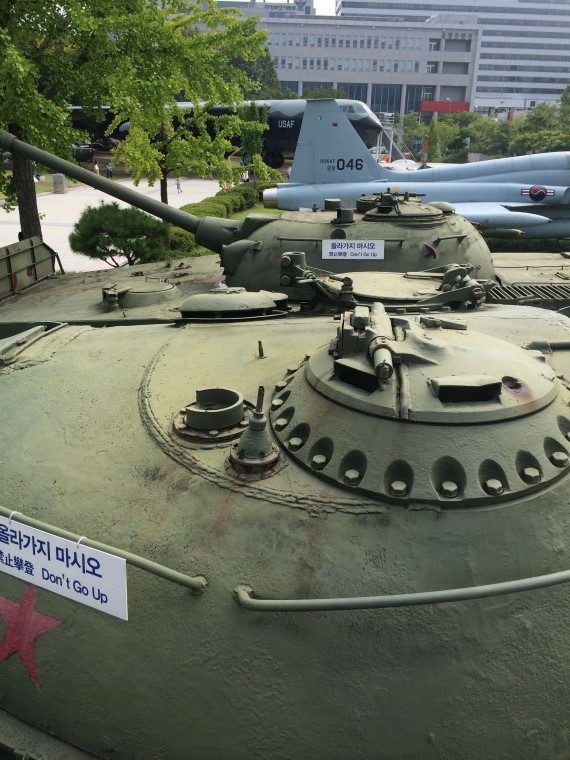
[0,131,494,286]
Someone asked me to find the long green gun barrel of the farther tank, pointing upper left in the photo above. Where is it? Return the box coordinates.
[0,130,254,253]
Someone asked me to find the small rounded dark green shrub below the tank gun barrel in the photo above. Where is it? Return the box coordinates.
[69,202,168,267]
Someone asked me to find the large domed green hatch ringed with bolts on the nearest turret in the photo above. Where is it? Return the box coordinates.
[270,304,570,507]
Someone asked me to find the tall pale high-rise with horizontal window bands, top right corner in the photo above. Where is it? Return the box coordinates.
[336,0,570,110]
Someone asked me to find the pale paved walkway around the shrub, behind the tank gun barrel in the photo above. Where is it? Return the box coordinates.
[0,177,220,272]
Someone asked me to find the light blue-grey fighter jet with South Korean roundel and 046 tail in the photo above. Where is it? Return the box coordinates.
[263,99,570,238]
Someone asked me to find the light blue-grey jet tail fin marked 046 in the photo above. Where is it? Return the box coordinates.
[289,99,390,185]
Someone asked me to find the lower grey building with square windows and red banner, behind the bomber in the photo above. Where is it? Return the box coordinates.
[220,3,479,114]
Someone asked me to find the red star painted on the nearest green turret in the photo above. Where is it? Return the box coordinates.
[0,586,62,686]
